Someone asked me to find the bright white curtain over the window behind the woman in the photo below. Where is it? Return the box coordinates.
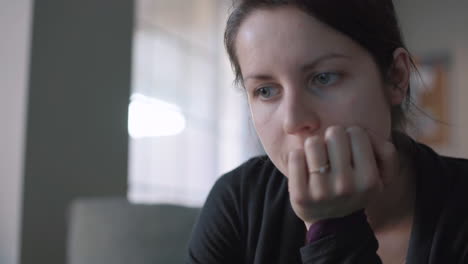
[128,0,262,206]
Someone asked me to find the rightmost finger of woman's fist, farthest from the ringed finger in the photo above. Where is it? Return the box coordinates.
[346,126,382,192]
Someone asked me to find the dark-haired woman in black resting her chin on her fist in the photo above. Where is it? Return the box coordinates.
[188,0,468,264]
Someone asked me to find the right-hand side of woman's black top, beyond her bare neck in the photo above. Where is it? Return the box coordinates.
[411,141,468,263]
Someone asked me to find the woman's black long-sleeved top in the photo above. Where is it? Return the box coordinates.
[187,141,468,264]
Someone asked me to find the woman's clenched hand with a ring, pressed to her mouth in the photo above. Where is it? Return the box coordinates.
[288,126,399,228]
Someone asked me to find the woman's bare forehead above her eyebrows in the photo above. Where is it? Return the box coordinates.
[236,6,360,73]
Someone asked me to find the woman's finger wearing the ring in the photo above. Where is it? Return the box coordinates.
[304,136,330,200]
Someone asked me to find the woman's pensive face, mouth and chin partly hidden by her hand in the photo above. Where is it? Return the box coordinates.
[236,7,391,176]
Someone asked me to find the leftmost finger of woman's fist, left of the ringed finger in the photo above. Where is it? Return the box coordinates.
[288,150,309,205]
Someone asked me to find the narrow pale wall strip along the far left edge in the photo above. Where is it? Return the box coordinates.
[0,0,32,264]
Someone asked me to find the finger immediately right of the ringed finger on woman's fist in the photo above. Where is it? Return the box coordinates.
[325,126,354,195]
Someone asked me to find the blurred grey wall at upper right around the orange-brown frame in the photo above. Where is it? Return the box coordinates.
[395,0,468,158]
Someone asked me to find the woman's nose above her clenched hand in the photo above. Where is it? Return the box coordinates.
[283,90,320,137]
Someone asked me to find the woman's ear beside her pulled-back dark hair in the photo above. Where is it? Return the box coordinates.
[388,48,411,105]
